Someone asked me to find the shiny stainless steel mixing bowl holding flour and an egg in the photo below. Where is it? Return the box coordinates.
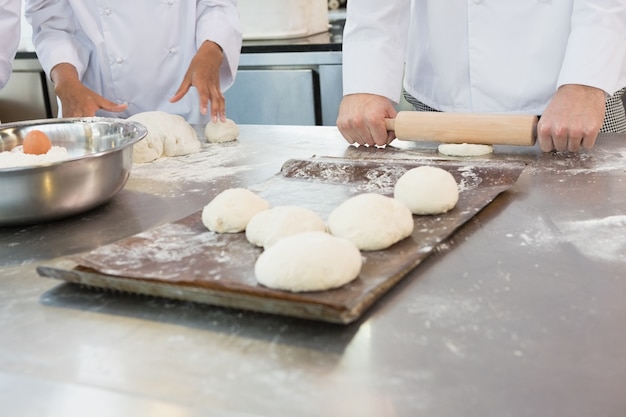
[0,117,147,226]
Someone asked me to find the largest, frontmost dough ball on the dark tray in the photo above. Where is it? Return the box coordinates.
[254,232,363,292]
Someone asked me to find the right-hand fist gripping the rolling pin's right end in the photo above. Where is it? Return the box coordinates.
[537,84,606,152]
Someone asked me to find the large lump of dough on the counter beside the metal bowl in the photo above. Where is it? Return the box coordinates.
[128,111,202,163]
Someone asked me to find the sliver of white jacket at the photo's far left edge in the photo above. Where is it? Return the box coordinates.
[0,0,22,89]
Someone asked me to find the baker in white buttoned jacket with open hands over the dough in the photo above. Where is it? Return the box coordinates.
[26,0,242,124]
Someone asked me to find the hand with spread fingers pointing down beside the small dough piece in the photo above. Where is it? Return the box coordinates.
[170,41,226,122]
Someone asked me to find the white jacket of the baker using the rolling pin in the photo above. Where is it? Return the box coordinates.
[343,0,626,114]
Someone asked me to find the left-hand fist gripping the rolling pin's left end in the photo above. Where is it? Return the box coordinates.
[337,94,398,146]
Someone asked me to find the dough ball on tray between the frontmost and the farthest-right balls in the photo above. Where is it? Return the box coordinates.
[328,193,413,250]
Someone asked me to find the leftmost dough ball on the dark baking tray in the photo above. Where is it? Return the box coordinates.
[202,188,270,233]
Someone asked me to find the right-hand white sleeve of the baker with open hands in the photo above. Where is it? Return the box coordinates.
[196,0,242,91]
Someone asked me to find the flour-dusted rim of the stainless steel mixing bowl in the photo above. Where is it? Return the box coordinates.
[0,116,148,173]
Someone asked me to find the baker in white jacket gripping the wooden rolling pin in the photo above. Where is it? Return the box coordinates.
[337,0,626,152]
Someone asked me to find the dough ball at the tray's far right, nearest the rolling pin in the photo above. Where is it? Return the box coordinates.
[393,166,459,214]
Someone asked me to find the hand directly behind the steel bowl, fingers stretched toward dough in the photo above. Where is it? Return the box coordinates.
[50,63,128,117]
